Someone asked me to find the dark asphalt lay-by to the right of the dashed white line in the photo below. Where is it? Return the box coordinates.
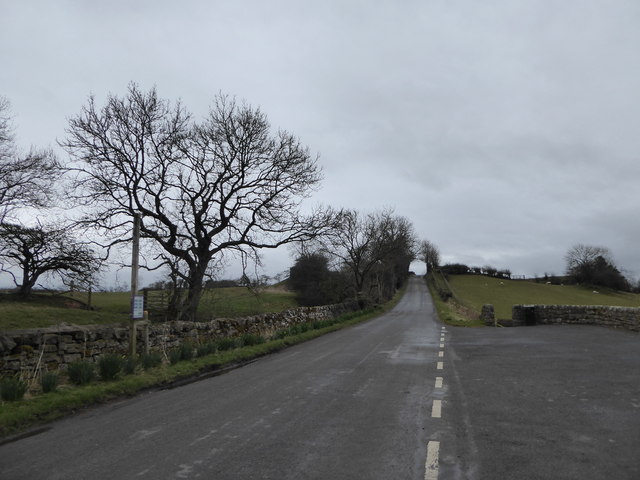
[440,318,640,480]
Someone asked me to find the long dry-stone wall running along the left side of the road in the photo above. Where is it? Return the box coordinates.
[0,304,358,376]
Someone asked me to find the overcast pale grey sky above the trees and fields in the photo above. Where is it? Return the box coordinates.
[0,0,640,283]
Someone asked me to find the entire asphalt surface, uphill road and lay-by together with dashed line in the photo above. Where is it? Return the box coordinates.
[0,278,640,480]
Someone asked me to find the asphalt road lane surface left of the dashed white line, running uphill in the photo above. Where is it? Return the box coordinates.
[0,279,440,480]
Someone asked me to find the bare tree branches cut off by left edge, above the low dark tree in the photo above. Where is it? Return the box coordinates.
[0,98,60,221]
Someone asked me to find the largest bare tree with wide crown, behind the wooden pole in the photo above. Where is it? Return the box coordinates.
[61,84,333,319]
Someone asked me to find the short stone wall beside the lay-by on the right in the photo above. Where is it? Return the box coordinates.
[511,305,640,332]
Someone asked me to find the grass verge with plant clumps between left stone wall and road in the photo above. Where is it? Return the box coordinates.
[0,289,404,438]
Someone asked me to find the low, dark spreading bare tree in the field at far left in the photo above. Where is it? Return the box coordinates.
[0,222,100,297]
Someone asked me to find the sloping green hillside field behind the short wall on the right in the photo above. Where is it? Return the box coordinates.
[448,275,640,319]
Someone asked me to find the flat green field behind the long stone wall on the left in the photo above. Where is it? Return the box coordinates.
[0,287,298,330]
